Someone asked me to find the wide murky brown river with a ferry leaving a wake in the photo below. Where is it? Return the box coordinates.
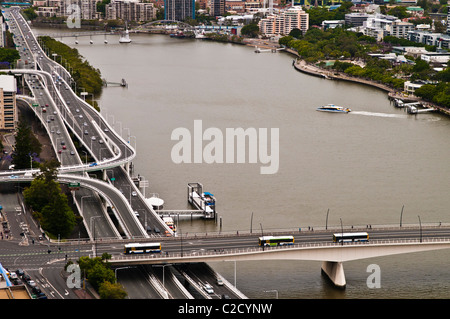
[35,29,450,299]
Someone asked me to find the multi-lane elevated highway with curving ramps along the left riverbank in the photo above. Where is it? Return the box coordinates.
[0,7,172,238]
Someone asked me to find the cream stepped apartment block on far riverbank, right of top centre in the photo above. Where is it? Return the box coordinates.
[258,7,309,36]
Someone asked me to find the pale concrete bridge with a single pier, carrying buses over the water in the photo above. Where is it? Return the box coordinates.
[109,226,450,288]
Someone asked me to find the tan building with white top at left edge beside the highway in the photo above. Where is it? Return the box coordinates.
[0,75,18,131]
